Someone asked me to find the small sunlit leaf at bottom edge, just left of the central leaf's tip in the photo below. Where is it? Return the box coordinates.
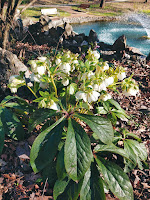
[53,178,70,200]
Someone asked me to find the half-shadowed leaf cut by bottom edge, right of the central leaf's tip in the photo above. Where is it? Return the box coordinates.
[80,163,106,200]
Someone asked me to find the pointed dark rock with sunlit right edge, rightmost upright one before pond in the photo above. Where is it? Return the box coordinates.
[112,35,127,51]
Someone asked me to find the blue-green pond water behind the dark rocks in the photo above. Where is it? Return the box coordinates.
[72,19,150,55]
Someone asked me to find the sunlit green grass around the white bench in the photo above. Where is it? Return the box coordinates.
[21,7,70,21]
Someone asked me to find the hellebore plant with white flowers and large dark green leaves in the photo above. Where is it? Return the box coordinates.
[1,49,147,200]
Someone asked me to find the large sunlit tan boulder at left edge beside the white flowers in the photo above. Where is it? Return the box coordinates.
[0,48,30,91]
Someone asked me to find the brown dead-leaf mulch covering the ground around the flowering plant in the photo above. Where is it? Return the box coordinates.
[0,43,150,200]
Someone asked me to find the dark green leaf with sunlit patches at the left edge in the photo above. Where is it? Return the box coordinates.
[1,108,25,140]
